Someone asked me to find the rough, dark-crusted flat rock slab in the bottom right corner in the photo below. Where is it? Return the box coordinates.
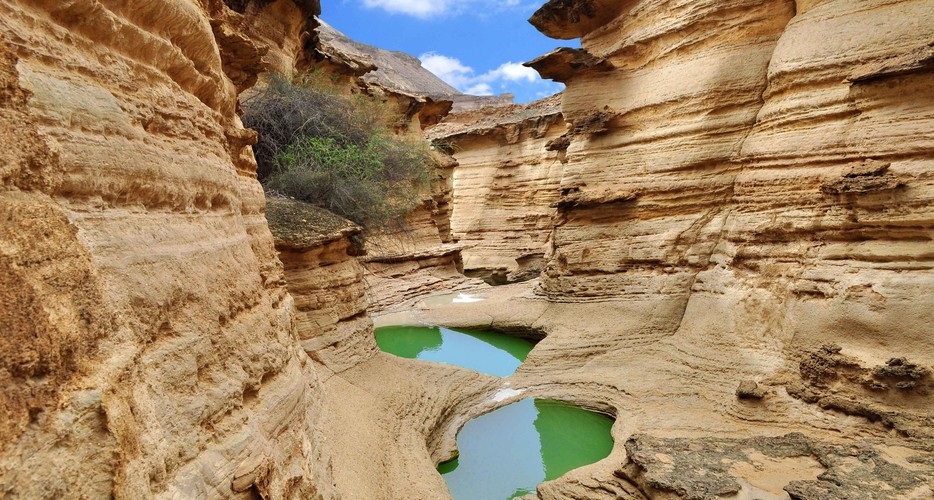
[616,434,931,500]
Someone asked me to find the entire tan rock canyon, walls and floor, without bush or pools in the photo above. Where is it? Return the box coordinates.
[0,0,934,499]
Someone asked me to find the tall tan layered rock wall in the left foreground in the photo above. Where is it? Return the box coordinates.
[0,0,333,498]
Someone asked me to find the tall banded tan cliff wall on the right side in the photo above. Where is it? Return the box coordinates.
[532,0,934,357]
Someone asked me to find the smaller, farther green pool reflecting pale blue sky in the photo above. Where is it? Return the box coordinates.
[376,326,535,377]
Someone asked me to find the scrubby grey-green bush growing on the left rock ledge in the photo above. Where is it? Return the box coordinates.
[243,73,434,231]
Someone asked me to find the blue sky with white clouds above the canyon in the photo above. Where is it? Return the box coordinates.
[321,0,576,103]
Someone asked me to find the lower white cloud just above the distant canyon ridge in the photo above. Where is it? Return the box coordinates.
[419,52,550,99]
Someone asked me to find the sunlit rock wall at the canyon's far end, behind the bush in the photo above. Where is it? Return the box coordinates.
[427,97,566,284]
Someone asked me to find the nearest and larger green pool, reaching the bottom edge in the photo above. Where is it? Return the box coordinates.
[438,399,613,500]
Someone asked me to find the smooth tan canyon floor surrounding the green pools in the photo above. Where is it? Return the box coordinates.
[310,280,934,499]
